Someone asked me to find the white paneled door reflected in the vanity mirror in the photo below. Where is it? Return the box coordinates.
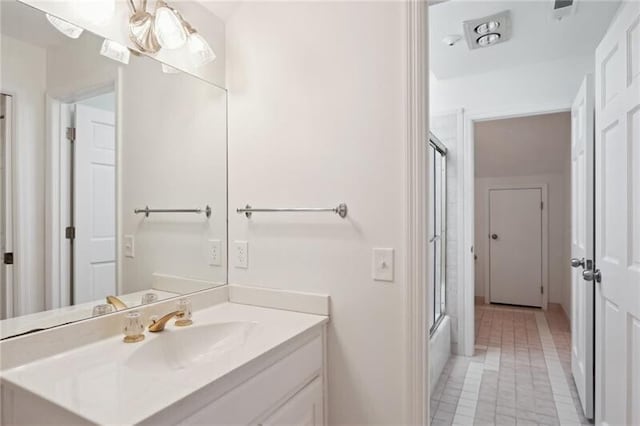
[73,104,116,303]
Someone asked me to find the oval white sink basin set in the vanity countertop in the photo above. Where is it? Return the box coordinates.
[125,321,258,373]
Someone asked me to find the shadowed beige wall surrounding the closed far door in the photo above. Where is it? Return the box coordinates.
[474,112,571,312]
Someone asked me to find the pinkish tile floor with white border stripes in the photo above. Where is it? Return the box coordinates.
[431,305,591,426]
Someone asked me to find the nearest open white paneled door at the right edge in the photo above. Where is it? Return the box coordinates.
[586,1,640,425]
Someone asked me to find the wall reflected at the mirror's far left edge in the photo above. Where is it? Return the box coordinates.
[0,35,46,315]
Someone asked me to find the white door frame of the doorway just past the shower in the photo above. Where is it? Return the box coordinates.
[458,102,571,356]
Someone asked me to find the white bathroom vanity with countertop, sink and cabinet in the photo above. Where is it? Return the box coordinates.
[0,286,328,425]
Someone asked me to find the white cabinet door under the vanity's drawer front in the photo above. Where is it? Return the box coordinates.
[259,378,324,426]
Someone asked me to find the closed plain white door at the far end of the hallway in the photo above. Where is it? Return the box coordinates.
[488,188,542,307]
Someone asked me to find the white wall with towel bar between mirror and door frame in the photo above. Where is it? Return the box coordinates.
[227,2,407,425]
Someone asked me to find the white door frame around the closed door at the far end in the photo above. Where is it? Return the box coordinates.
[484,183,549,310]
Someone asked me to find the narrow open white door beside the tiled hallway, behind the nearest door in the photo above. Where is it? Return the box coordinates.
[571,75,595,419]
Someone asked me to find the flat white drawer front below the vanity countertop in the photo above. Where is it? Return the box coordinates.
[180,337,323,425]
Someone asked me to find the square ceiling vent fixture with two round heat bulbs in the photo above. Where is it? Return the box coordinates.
[462,10,511,50]
